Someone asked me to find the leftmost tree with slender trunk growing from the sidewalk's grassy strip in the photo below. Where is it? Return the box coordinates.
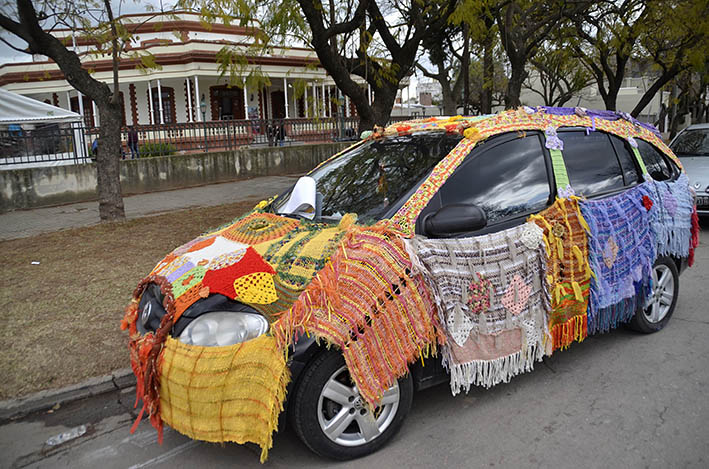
[0,0,169,221]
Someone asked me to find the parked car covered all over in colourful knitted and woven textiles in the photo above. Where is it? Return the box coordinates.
[122,107,699,461]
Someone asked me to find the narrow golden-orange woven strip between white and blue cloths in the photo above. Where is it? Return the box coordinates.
[529,197,591,350]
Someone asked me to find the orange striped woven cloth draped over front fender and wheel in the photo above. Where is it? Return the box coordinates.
[271,225,443,407]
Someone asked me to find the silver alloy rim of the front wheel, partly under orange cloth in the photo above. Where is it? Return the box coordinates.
[317,366,400,446]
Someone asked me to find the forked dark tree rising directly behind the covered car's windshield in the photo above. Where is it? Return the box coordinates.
[245,0,456,129]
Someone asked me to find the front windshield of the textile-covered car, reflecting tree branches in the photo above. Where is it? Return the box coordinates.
[273,132,462,223]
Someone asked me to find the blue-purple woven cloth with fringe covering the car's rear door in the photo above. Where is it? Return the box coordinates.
[580,182,659,334]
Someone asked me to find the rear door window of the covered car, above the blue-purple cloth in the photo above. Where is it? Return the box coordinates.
[559,131,625,196]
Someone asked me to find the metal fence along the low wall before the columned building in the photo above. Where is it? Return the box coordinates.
[0,117,418,169]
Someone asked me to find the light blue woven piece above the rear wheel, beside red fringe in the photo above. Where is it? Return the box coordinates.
[649,173,694,258]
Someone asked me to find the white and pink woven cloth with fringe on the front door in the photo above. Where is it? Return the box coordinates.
[407,223,551,395]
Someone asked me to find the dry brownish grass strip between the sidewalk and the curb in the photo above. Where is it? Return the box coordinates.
[0,200,257,399]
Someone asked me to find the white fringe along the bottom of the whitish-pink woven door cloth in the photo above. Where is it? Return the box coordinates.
[443,342,545,396]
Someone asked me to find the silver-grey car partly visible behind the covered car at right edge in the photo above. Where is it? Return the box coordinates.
[670,124,709,216]
